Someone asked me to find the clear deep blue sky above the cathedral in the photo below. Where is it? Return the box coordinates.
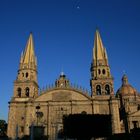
[0,0,140,120]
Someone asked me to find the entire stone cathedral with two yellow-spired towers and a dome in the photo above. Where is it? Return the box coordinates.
[7,30,140,140]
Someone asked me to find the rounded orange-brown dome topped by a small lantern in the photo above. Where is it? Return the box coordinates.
[116,75,137,96]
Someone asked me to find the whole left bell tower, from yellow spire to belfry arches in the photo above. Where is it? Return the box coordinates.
[14,33,38,98]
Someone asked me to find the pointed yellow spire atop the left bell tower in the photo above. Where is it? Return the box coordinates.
[21,33,36,65]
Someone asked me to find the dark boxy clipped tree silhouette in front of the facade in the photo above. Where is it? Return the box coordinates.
[63,114,112,140]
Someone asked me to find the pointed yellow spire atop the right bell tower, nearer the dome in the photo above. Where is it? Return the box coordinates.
[93,30,108,65]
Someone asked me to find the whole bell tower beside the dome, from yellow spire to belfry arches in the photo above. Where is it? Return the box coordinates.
[90,30,114,96]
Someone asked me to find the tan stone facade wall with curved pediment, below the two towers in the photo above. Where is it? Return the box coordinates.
[8,89,120,140]
